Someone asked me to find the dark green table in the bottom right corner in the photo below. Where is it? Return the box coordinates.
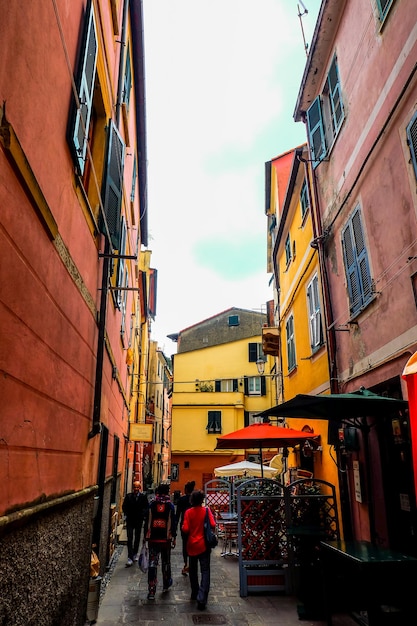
[320,540,417,626]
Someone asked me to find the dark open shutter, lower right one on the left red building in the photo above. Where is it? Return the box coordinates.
[101,120,125,250]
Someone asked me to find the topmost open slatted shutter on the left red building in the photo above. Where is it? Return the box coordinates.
[71,2,98,175]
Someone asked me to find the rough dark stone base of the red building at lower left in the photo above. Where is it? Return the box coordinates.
[0,492,94,626]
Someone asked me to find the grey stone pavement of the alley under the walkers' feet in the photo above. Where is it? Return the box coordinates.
[87,539,356,626]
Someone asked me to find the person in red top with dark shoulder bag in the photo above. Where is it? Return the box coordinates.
[182,489,216,611]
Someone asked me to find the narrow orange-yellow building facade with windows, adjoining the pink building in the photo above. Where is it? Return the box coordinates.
[266,146,338,487]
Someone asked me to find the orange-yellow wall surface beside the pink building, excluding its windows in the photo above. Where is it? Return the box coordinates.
[275,150,340,510]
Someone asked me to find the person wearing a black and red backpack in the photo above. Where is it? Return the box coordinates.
[145,483,177,600]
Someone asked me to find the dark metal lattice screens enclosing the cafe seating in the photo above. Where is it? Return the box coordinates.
[236,478,339,597]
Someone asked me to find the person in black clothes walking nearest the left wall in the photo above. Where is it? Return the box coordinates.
[122,480,149,567]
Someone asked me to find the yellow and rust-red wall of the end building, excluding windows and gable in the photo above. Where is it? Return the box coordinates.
[172,335,276,489]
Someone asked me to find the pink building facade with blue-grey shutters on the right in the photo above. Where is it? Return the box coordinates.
[294,0,417,553]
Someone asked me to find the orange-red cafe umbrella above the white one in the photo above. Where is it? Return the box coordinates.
[216,424,317,476]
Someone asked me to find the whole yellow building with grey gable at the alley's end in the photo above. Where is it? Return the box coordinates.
[171,308,276,490]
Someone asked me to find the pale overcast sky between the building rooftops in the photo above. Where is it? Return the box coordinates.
[143,0,320,357]
